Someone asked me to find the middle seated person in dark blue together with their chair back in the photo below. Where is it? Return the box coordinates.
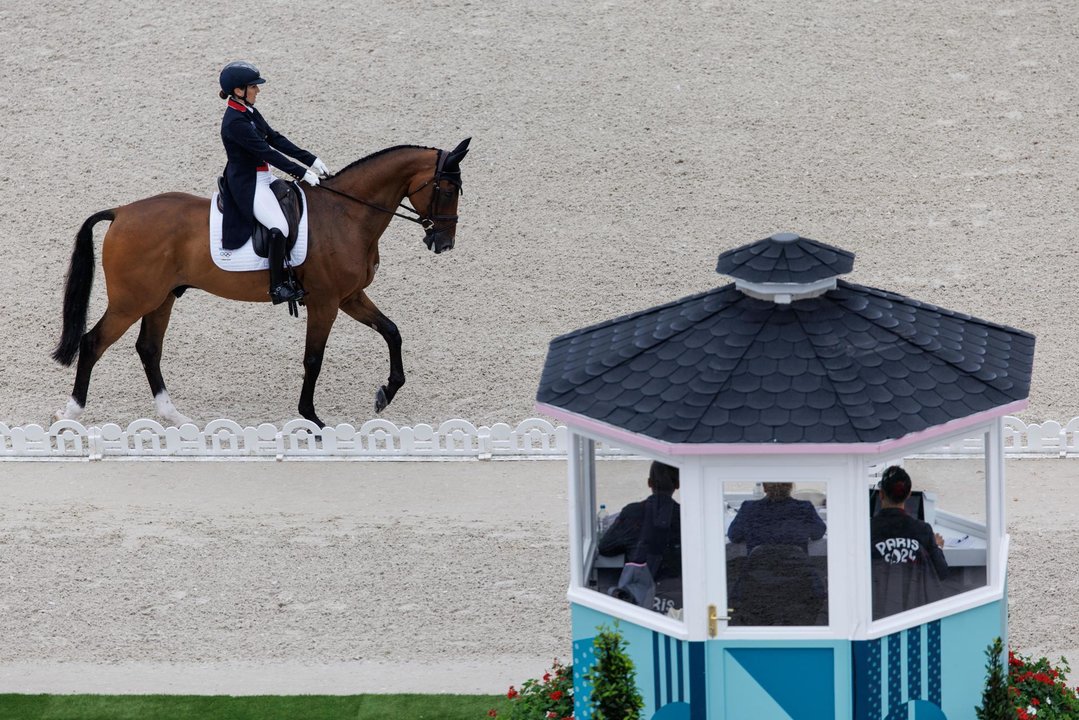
[727,483,828,626]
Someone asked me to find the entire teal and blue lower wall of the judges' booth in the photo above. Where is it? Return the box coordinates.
[572,601,1007,720]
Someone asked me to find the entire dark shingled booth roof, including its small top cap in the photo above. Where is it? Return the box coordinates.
[536,236,1035,444]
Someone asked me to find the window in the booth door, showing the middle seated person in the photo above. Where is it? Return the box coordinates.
[723,481,828,627]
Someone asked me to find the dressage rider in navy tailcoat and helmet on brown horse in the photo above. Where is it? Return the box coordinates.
[213,60,329,304]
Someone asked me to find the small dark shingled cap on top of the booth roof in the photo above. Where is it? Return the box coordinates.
[715,232,855,283]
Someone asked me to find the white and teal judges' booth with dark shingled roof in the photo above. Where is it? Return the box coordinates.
[536,234,1034,720]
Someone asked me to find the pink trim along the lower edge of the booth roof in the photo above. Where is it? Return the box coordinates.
[535,398,1029,456]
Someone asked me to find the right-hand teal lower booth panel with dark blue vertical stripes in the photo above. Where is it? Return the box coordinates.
[851,601,1007,720]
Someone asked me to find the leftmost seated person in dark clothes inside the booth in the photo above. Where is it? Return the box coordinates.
[599,462,682,613]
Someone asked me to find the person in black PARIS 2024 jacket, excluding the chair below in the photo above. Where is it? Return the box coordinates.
[870,465,947,579]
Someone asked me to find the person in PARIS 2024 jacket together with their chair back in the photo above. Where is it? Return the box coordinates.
[870,465,948,620]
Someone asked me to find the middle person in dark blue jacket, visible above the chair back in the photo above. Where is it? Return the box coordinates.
[727,483,828,553]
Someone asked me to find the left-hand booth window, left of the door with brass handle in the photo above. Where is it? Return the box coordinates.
[585,460,682,619]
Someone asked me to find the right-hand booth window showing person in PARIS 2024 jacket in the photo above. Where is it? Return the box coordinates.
[868,457,988,620]
